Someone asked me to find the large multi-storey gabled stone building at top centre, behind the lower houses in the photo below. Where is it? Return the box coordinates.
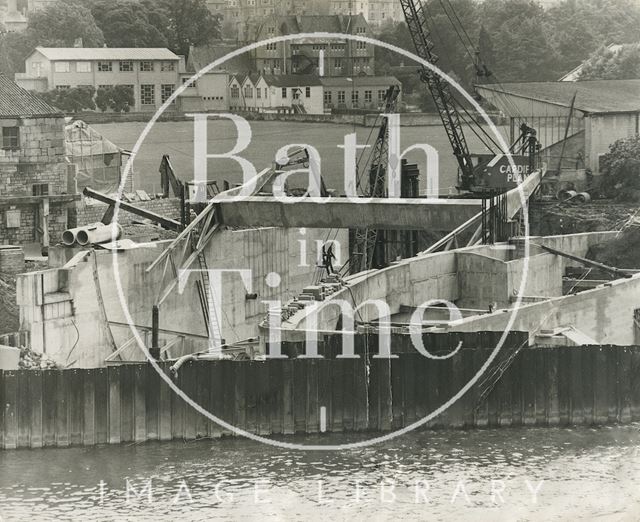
[252,15,375,76]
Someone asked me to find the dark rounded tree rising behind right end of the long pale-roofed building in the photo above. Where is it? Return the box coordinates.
[156,0,221,56]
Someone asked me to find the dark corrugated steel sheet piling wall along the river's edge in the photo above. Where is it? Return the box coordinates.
[0,332,640,449]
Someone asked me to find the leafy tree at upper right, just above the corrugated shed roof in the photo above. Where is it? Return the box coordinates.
[578,44,640,80]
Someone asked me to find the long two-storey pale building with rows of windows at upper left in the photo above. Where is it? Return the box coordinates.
[16,47,184,111]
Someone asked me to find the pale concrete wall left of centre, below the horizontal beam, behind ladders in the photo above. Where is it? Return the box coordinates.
[17,228,347,367]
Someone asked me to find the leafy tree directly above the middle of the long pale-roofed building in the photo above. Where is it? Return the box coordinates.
[90,0,169,47]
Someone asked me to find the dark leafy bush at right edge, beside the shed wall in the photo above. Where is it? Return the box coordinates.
[601,135,640,200]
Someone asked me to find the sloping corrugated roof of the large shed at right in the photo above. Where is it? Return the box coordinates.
[477,79,640,114]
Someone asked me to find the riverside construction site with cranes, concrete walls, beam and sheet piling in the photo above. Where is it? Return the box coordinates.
[0,0,640,449]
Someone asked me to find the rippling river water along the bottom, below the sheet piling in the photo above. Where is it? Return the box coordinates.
[0,425,640,521]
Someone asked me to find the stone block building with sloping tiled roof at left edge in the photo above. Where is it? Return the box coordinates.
[0,74,78,247]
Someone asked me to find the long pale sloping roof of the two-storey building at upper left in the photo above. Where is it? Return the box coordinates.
[36,47,180,61]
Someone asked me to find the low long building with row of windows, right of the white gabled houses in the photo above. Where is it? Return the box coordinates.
[321,76,402,110]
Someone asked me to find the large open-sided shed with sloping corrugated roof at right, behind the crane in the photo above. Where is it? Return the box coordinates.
[477,80,640,175]
